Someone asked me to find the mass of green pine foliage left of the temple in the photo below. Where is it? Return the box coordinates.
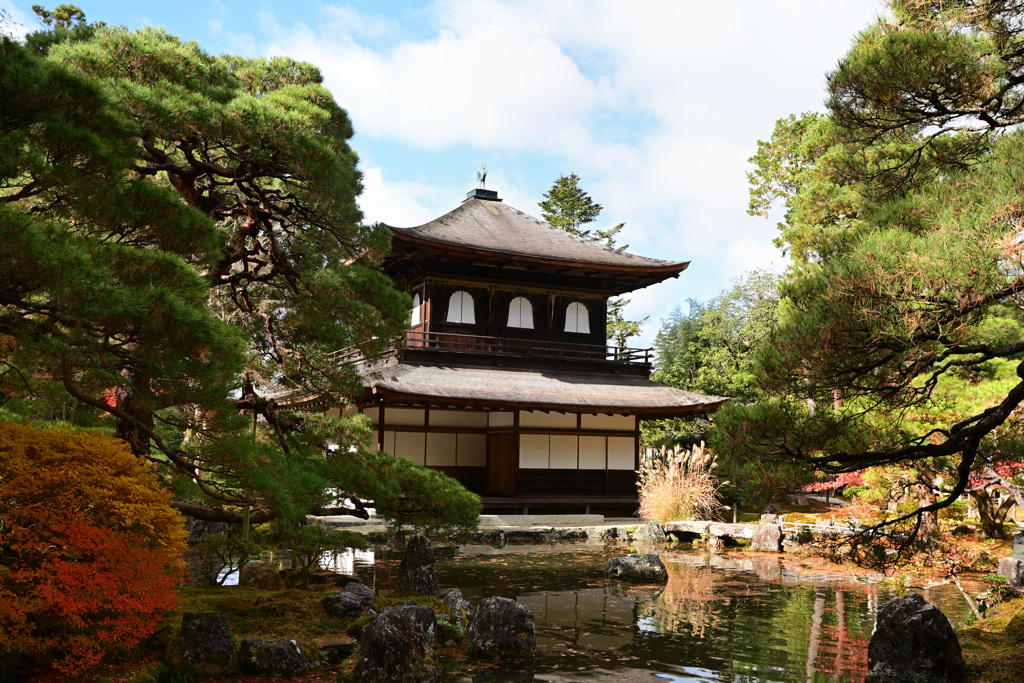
[0,13,409,520]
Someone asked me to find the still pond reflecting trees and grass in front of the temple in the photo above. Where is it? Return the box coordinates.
[338,544,973,683]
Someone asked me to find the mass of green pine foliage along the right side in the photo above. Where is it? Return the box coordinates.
[713,0,1024,538]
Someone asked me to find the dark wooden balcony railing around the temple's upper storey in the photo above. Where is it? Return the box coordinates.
[406,330,653,365]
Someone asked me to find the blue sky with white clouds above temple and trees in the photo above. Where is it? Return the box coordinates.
[0,0,882,346]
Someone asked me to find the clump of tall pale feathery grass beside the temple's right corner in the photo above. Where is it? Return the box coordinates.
[637,441,728,524]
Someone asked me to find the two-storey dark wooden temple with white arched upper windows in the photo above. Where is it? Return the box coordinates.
[333,189,726,512]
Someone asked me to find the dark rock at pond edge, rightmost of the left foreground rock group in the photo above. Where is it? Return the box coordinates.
[466,596,537,658]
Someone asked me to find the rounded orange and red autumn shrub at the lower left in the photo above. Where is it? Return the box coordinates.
[0,422,186,676]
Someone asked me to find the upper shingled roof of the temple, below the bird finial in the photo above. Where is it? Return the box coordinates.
[389,198,689,274]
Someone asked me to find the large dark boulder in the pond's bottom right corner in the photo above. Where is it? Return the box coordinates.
[864,593,967,683]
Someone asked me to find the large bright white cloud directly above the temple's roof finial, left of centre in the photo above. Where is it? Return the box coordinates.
[268,12,612,151]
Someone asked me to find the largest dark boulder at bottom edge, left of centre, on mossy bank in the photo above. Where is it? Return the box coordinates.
[352,609,437,683]
